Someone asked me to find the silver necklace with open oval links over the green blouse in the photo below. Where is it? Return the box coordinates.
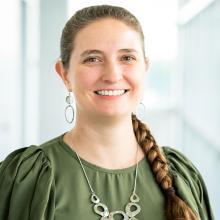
[71,140,141,220]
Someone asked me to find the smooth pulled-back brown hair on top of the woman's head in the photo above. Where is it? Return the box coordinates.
[60,5,144,68]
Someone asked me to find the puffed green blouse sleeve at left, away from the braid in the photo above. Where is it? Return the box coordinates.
[0,146,55,220]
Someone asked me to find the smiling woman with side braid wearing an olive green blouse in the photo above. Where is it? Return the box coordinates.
[0,5,213,220]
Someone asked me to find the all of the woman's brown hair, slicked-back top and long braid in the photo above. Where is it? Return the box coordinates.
[61,5,197,220]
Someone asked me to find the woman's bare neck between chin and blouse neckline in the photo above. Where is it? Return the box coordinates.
[64,112,144,169]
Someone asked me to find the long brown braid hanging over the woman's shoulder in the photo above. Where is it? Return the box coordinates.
[132,114,197,220]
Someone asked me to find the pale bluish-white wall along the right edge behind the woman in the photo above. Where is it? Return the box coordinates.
[179,0,220,219]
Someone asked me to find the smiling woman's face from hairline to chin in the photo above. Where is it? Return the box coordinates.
[58,18,148,117]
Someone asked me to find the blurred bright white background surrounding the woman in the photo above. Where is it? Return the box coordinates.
[0,0,220,219]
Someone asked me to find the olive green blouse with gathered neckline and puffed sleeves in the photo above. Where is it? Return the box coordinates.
[0,135,214,220]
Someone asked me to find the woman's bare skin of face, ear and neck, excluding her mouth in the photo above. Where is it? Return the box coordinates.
[56,18,148,169]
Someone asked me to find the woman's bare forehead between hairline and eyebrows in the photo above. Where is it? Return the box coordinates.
[73,18,142,53]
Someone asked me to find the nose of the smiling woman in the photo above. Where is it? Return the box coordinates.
[102,62,123,83]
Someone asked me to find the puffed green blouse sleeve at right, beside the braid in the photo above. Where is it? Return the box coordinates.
[162,147,214,220]
